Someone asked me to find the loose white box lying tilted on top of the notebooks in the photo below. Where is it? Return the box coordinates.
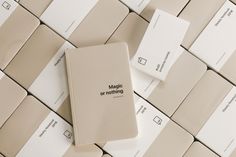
[131,10,189,80]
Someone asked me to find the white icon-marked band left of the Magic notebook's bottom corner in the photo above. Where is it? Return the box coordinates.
[16,112,73,157]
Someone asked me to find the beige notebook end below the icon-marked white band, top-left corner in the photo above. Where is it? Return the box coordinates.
[0,6,39,69]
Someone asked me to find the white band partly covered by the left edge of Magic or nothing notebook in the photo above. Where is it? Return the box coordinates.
[29,42,74,111]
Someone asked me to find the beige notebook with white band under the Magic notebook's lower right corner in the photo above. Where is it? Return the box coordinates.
[101,96,193,157]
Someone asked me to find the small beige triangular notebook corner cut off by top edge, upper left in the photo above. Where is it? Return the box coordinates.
[20,0,53,17]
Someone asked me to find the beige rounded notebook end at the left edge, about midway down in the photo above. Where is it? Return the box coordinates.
[0,75,27,128]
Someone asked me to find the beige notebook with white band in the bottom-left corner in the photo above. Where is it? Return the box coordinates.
[0,96,102,157]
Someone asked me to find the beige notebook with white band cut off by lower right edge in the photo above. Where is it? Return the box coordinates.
[172,71,236,156]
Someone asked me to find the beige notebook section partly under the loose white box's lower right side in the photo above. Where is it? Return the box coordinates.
[148,51,207,116]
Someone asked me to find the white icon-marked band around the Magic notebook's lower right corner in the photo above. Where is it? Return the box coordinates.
[104,98,169,157]
